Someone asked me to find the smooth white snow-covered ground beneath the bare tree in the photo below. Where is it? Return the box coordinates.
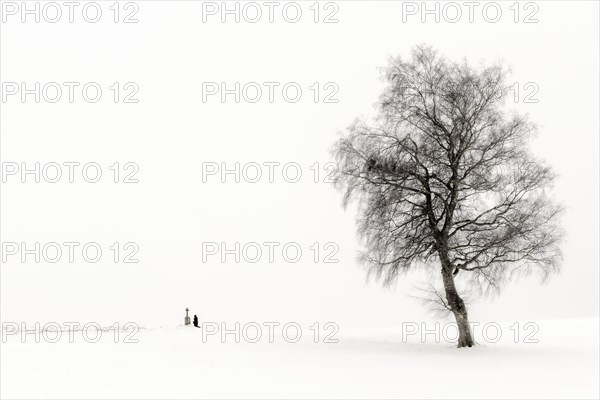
[1,318,599,399]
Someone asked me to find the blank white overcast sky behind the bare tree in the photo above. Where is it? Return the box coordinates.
[0,1,599,329]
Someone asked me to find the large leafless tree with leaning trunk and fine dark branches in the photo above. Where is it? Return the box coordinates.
[334,46,561,347]
